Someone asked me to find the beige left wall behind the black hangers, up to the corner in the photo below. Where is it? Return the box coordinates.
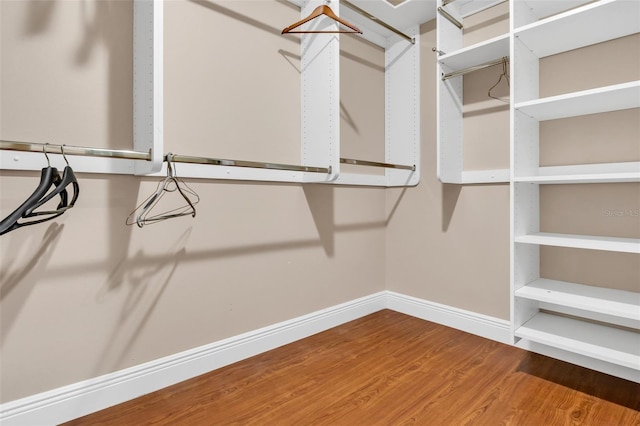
[0,0,386,402]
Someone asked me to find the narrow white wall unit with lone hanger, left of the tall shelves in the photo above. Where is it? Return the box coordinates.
[436,0,510,184]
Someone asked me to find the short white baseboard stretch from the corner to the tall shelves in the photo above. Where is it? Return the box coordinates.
[387,291,511,344]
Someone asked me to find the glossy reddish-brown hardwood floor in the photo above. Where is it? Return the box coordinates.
[67,310,640,426]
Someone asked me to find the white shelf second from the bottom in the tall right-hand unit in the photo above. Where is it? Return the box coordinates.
[515,278,640,321]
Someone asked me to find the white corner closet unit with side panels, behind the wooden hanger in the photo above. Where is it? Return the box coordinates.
[298,0,434,187]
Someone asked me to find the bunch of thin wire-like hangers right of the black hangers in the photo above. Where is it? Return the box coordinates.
[126,153,200,228]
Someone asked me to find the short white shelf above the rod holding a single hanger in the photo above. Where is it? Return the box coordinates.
[438,34,509,72]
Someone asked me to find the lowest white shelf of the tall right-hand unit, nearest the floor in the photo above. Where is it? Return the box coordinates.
[515,313,640,370]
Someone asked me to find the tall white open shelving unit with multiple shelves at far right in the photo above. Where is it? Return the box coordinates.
[510,0,640,382]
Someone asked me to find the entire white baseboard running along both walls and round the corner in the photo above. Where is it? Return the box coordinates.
[0,291,510,426]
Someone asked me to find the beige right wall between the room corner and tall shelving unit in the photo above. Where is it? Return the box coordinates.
[386,8,509,320]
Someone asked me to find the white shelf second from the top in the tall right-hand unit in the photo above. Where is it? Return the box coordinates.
[514,81,640,121]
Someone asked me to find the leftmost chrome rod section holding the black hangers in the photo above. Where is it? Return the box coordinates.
[0,141,151,161]
